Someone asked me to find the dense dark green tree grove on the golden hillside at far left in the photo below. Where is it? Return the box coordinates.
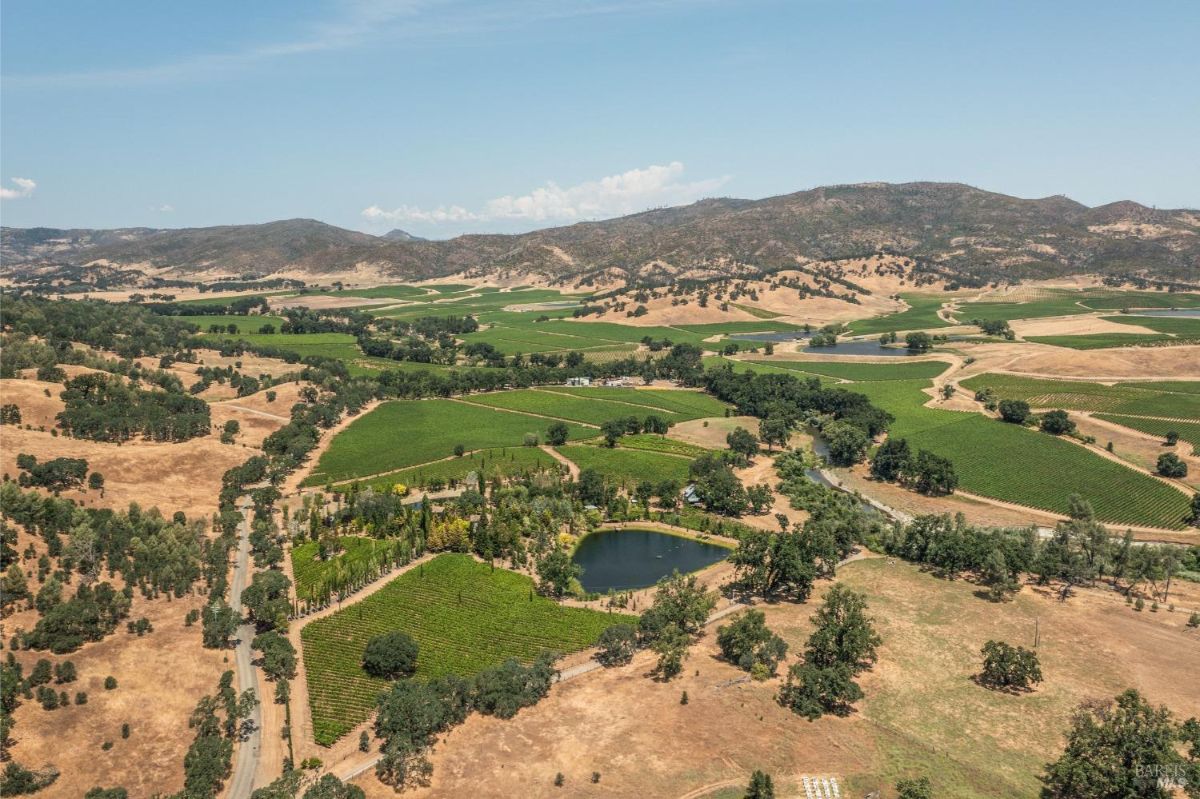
[58,373,212,441]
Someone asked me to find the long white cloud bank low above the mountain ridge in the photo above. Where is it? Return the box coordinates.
[362,161,728,224]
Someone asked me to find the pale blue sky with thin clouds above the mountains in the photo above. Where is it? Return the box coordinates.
[0,0,1200,238]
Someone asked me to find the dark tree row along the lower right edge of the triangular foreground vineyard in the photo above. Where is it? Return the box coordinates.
[374,651,559,791]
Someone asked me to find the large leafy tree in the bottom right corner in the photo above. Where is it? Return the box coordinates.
[1042,689,1196,799]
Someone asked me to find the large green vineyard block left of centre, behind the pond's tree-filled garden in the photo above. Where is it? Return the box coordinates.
[305,400,596,486]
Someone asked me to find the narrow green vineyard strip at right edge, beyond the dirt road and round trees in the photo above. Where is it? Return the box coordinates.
[961,373,1200,420]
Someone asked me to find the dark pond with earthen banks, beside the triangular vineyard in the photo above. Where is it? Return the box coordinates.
[574,528,730,594]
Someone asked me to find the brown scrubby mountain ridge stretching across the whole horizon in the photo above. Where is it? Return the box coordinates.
[0,182,1200,283]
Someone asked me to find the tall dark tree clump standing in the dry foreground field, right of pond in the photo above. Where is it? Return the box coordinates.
[779,584,882,721]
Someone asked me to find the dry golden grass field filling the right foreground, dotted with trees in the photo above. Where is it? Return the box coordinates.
[358,558,1200,799]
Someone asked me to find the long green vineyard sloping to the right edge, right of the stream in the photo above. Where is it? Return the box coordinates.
[853,380,1188,529]
